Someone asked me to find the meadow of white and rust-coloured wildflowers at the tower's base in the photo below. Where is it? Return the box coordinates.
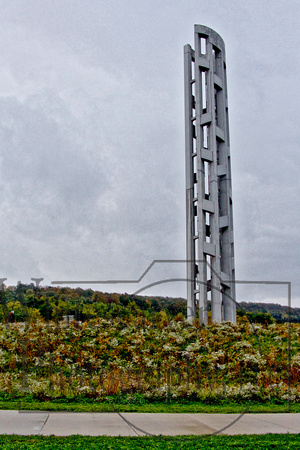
[0,318,300,404]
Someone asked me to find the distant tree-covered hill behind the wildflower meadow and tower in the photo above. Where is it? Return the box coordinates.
[0,284,300,323]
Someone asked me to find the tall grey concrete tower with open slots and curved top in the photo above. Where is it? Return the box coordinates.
[184,25,236,324]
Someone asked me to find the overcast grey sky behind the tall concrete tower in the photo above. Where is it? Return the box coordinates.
[0,0,300,306]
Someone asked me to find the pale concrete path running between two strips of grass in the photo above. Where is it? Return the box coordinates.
[0,410,300,436]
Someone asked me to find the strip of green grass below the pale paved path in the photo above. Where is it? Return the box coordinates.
[0,434,300,450]
